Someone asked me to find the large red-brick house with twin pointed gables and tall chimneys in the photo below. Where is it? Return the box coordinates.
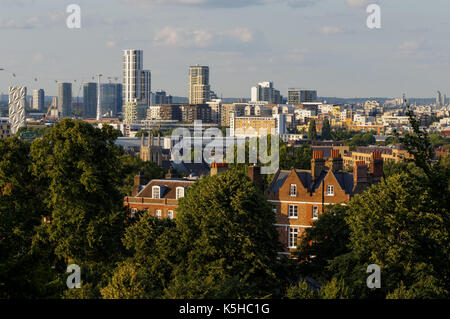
[265,150,383,255]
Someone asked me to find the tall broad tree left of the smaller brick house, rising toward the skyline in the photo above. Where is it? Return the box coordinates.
[31,119,125,263]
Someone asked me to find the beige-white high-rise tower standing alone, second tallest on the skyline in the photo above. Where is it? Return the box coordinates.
[189,65,211,104]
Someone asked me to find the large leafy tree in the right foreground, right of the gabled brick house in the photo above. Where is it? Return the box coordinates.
[330,173,450,298]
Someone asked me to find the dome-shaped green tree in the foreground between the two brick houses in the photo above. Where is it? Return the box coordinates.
[166,171,280,298]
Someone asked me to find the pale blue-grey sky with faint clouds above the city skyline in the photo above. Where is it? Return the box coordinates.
[0,0,450,97]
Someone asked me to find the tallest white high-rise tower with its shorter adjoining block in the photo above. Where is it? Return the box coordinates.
[123,50,151,105]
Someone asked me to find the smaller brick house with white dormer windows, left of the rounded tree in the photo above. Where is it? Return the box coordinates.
[124,173,195,219]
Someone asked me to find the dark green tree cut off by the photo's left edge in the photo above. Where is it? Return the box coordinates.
[0,137,62,298]
